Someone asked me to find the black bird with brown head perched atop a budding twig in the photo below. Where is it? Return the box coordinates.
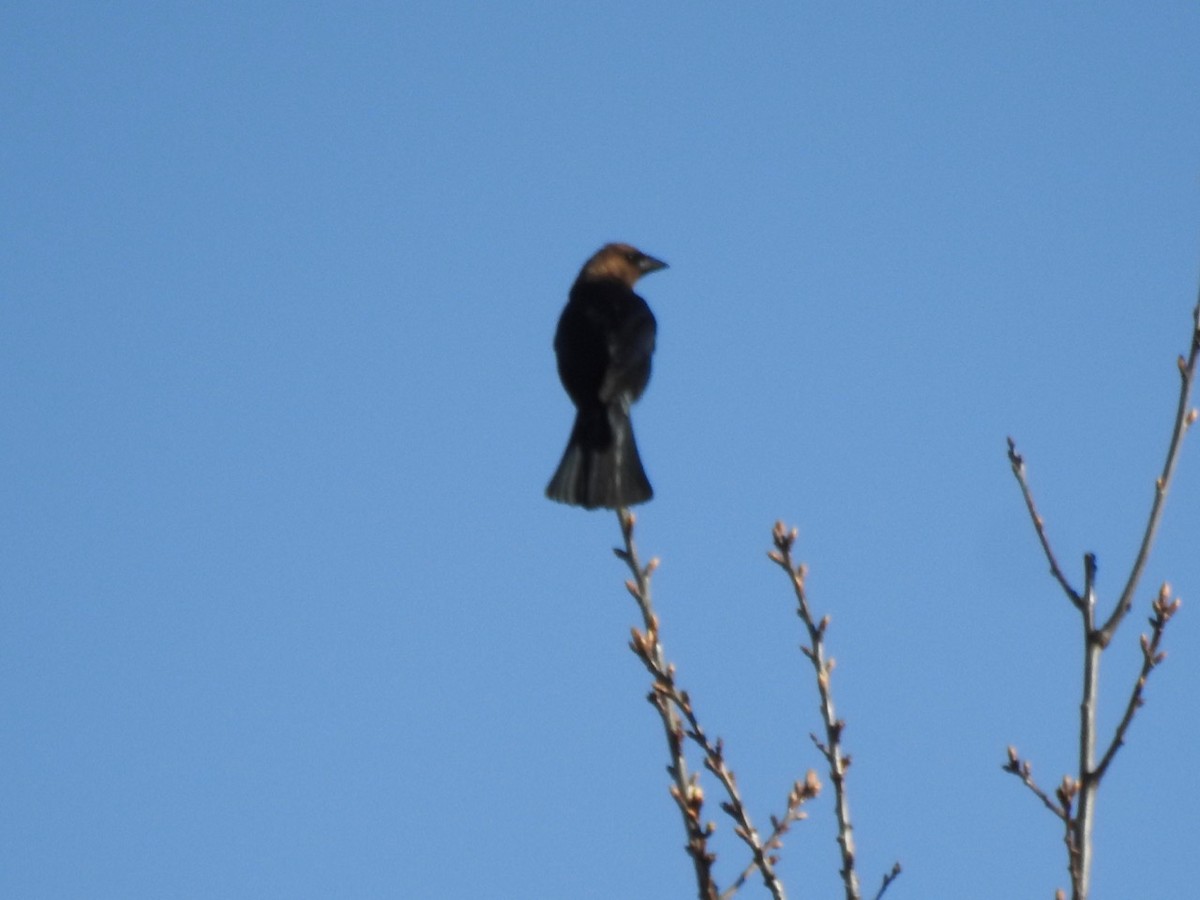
[546,244,667,509]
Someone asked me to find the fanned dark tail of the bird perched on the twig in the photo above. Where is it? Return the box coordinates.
[546,404,654,509]
